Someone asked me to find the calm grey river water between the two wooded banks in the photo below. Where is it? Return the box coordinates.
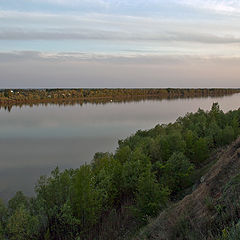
[0,94,240,200]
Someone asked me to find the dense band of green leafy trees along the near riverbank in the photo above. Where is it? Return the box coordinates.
[0,103,240,240]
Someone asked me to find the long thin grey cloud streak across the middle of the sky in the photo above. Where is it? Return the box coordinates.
[0,28,240,44]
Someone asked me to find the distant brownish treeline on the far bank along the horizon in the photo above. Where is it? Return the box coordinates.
[0,88,240,106]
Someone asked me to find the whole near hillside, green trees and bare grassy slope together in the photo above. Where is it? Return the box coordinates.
[0,103,240,240]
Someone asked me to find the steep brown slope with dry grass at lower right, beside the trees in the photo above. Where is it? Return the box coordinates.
[135,138,240,240]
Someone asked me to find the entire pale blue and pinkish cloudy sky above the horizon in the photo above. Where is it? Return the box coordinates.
[0,0,240,88]
